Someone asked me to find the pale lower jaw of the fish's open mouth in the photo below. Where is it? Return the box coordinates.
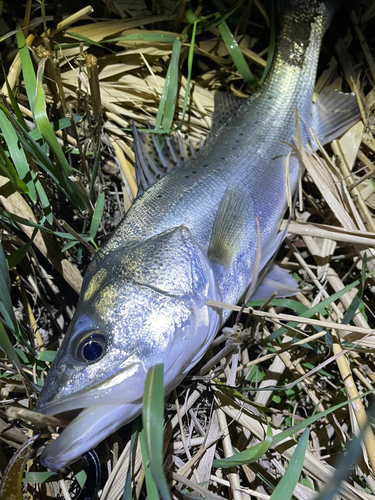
[40,402,142,470]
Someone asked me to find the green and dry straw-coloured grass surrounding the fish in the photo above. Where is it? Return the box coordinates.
[0,1,375,500]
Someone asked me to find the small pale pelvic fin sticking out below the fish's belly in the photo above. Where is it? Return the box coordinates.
[250,264,299,300]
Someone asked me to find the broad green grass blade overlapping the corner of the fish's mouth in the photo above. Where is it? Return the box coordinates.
[142,363,171,500]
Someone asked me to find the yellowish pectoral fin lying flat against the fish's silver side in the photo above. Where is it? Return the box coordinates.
[207,185,255,269]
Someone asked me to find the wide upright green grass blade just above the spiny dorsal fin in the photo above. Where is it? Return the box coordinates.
[155,40,181,132]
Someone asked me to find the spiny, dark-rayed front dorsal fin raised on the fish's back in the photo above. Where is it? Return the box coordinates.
[132,124,196,198]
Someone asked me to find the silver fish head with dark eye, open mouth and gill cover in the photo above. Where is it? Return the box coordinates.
[37,226,221,469]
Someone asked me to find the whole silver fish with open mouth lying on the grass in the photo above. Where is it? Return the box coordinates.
[36,0,358,470]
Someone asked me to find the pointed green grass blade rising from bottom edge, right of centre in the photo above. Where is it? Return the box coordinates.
[270,429,310,500]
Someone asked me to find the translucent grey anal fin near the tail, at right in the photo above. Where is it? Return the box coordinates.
[312,87,360,145]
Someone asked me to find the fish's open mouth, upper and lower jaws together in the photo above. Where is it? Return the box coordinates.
[37,367,145,470]
